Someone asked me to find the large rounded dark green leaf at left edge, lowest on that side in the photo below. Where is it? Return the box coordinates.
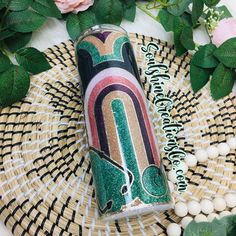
[0,65,30,107]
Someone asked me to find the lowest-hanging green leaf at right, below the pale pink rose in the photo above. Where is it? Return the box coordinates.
[211,63,235,100]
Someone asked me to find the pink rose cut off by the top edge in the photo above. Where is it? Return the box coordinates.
[55,0,94,13]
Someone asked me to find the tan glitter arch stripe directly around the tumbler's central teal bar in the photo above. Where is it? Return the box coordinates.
[102,91,149,172]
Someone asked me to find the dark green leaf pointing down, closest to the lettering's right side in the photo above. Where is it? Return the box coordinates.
[190,63,212,93]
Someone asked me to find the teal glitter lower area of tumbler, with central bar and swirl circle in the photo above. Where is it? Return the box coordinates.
[90,99,171,214]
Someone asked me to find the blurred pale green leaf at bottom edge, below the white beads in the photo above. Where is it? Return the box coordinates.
[183,220,226,236]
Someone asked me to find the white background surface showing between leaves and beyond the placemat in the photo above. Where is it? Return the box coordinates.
[0,0,236,236]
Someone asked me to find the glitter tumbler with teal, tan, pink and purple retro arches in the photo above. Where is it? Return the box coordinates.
[75,25,171,220]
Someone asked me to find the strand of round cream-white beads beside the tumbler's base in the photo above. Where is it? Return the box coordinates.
[167,137,236,236]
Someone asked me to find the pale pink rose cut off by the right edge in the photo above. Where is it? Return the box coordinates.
[212,18,236,47]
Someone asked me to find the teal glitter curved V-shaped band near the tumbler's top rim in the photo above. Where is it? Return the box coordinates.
[77,36,129,66]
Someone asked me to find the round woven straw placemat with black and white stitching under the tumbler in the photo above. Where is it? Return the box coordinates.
[0,34,236,236]
